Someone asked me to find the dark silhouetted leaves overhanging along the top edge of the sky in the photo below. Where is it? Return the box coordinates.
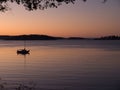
[0,0,107,12]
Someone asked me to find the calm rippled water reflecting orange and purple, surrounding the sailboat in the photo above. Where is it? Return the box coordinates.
[0,40,120,90]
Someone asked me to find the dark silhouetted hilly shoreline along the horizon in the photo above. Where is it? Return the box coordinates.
[0,34,120,40]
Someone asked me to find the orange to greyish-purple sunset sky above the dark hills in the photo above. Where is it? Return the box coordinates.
[0,0,120,37]
